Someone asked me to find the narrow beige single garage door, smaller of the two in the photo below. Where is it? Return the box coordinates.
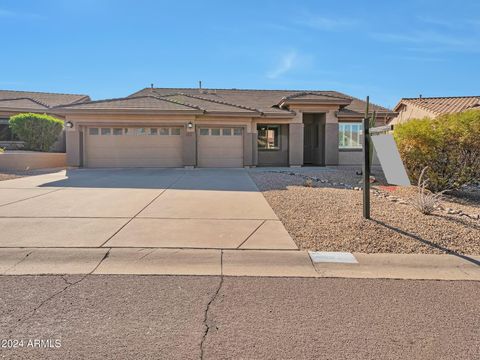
[197,127,243,167]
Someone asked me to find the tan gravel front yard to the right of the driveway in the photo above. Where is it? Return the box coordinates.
[250,167,480,255]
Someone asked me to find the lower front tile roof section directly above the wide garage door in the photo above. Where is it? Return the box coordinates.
[55,95,203,112]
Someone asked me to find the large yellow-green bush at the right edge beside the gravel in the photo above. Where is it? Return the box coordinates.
[394,110,480,192]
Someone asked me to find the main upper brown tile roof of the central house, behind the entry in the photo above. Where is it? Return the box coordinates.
[130,88,393,116]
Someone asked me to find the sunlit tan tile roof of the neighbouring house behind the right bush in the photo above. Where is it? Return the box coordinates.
[394,96,480,115]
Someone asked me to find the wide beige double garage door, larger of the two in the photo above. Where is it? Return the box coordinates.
[85,127,183,167]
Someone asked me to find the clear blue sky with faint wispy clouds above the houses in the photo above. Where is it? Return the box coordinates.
[0,0,480,107]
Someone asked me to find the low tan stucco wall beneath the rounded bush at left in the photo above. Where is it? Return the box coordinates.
[0,151,66,170]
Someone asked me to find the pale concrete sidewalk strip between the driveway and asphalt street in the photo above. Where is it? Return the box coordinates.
[0,248,480,281]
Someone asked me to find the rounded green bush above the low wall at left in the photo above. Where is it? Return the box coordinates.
[9,113,63,151]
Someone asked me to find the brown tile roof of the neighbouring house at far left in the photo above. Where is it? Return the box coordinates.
[0,90,90,110]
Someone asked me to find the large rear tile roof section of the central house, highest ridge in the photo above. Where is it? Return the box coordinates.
[130,88,392,115]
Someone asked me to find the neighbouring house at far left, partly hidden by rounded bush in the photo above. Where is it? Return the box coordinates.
[0,90,90,151]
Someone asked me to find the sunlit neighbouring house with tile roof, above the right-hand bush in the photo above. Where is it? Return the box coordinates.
[390,96,480,125]
